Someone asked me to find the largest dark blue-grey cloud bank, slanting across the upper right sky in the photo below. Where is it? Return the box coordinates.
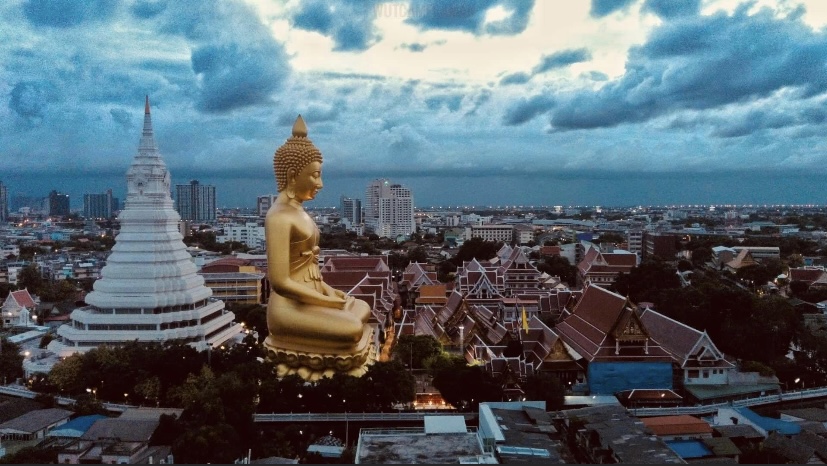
[540,6,827,130]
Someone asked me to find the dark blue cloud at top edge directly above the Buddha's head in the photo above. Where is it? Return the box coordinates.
[293,0,380,52]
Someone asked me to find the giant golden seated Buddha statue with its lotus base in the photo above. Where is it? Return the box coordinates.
[264,115,375,380]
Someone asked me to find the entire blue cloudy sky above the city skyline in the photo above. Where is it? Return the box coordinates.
[0,0,827,207]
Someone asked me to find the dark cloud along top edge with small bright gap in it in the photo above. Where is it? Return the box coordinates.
[406,0,534,35]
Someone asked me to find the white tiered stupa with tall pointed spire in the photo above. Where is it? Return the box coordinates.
[49,97,242,356]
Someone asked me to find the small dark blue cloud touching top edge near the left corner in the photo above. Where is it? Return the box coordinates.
[23,0,118,28]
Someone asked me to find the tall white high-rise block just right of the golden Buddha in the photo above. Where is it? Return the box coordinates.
[364,179,416,238]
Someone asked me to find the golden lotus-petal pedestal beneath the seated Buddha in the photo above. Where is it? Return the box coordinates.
[264,325,376,381]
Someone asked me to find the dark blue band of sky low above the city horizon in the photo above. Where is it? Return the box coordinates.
[0,167,827,210]
